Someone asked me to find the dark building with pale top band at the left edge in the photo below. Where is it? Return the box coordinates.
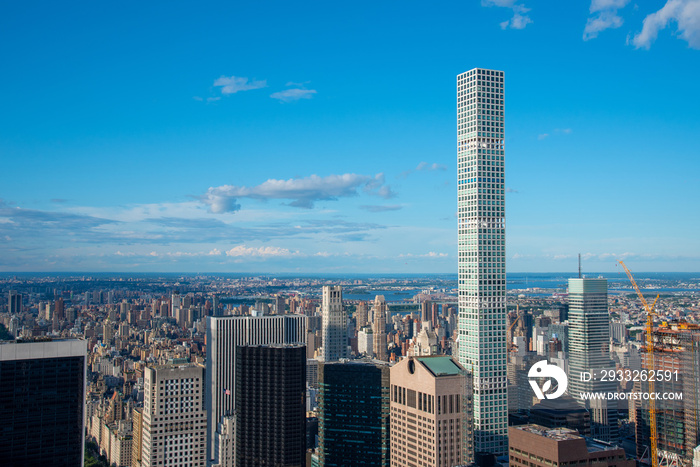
[0,340,87,467]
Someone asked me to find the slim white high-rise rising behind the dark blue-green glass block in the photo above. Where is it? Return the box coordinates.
[321,285,348,362]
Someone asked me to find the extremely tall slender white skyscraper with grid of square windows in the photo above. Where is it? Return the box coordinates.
[457,68,508,454]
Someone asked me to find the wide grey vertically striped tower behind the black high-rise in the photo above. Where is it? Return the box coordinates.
[206,315,309,459]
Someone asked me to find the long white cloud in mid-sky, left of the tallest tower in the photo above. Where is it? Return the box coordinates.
[199,173,395,213]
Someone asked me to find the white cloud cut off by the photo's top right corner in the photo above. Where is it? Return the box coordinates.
[632,0,700,49]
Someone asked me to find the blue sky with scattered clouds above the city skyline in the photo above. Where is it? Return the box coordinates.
[0,0,700,273]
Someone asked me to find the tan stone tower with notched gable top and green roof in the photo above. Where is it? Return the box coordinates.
[389,356,473,467]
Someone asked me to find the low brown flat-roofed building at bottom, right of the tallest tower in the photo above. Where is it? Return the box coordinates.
[508,425,635,467]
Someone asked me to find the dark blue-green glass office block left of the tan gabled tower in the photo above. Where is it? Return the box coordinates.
[318,362,390,467]
